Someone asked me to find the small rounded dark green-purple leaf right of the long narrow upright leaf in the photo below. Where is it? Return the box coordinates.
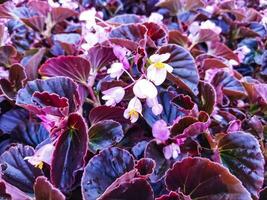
[89,120,123,153]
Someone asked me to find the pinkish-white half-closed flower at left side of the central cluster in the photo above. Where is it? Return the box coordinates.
[102,87,125,106]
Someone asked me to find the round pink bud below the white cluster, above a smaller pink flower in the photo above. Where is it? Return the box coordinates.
[152,119,171,142]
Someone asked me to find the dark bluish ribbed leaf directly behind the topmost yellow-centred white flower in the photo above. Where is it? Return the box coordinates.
[157,44,199,95]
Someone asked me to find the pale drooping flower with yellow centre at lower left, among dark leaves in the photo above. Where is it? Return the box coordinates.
[24,143,55,169]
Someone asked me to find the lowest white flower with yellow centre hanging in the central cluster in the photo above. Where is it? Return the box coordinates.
[123,97,142,123]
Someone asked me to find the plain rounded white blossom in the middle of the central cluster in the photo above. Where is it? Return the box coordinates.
[133,79,158,99]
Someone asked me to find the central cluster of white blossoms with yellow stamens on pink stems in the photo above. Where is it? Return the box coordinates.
[102,53,173,123]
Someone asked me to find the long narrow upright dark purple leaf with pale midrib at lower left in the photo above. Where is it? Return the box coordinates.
[51,113,88,192]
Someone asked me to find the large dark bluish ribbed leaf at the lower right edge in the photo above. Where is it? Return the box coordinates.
[218,131,264,199]
